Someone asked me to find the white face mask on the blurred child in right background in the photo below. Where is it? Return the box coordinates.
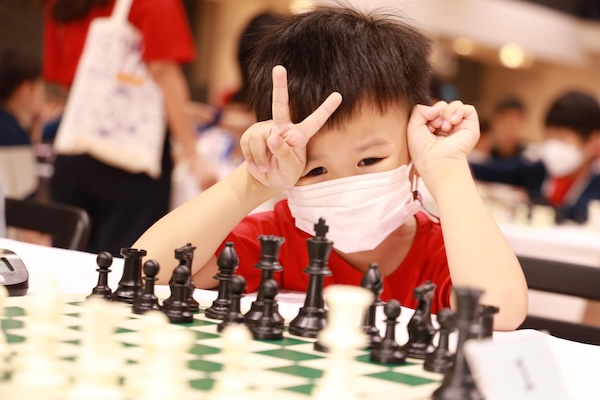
[540,139,583,176]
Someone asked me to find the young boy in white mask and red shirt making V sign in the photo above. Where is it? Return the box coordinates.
[134,8,527,329]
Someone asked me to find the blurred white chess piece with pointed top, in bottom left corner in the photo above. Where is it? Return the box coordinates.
[11,280,68,399]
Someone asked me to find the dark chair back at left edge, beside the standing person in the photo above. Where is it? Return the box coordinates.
[5,198,91,250]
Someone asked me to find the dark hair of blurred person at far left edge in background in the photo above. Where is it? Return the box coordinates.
[0,47,42,102]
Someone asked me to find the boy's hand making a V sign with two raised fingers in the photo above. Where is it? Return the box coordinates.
[240,65,342,191]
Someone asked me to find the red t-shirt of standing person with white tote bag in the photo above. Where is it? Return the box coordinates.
[43,0,196,87]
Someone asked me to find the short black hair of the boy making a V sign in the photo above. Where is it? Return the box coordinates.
[249,7,431,128]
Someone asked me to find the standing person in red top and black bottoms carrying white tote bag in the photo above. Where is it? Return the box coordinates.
[43,0,216,255]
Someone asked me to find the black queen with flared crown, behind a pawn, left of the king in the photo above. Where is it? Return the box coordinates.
[244,235,285,327]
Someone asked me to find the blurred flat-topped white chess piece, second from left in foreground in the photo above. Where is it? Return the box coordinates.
[68,298,125,400]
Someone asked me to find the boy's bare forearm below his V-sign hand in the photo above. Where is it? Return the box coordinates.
[133,164,277,284]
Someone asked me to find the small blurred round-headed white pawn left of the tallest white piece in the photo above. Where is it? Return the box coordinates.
[209,324,252,400]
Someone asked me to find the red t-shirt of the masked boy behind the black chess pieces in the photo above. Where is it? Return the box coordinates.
[216,200,452,313]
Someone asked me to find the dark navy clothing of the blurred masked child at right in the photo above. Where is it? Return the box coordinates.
[470,157,600,222]
